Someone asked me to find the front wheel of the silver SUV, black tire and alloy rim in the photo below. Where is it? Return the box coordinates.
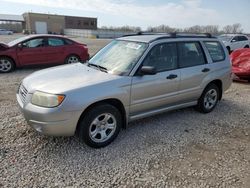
[78,104,122,148]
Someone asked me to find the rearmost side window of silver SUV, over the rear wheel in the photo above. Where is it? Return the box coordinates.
[204,42,225,62]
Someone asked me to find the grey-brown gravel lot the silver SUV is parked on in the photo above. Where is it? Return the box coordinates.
[0,36,250,188]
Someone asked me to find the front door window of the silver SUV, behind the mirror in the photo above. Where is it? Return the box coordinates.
[143,43,177,72]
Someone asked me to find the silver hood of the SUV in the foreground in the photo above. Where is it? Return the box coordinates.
[22,63,120,94]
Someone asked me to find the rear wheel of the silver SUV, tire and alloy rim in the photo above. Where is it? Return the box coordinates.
[197,84,219,113]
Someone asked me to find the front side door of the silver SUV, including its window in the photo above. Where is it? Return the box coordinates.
[130,43,180,116]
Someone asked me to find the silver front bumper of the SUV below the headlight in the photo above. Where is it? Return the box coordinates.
[16,93,81,136]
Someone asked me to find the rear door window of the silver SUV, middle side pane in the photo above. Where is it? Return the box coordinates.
[178,42,206,68]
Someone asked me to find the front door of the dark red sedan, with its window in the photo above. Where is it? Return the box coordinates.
[17,37,47,65]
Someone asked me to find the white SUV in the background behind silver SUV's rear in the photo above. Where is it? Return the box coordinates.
[218,34,250,53]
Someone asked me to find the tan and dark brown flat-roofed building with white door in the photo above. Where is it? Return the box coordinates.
[23,12,97,34]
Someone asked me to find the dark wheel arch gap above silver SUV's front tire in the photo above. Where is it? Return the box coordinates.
[76,98,127,133]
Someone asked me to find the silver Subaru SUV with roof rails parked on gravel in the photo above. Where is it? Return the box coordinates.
[16,33,231,148]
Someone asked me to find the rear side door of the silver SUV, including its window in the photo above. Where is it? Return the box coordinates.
[177,41,207,102]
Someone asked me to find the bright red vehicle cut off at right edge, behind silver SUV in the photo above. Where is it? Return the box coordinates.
[230,48,250,82]
